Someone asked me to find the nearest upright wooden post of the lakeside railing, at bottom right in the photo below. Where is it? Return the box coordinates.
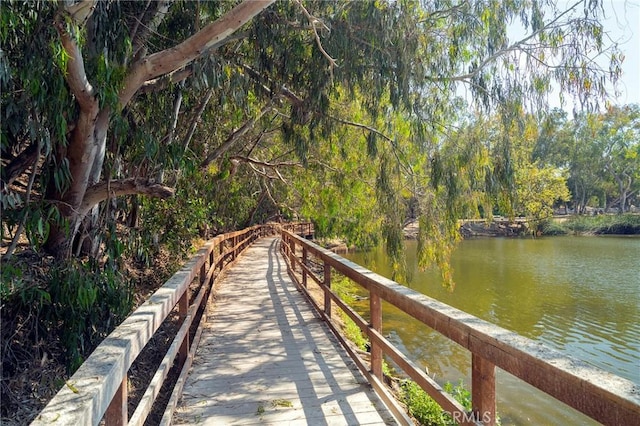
[471,353,496,426]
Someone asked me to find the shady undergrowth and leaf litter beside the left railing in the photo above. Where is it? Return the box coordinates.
[0,207,198,424]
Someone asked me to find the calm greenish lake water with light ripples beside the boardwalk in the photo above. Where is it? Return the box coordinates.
[345,237,640,425]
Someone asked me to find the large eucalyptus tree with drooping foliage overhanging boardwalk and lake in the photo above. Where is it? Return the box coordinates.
[0,0,620,266]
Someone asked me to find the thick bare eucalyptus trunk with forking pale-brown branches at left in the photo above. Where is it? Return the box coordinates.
[45,0,275,257]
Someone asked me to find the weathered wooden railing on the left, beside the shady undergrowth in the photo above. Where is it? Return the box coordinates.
[32,224,292,426]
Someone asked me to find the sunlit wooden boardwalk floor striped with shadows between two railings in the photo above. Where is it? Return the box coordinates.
[173,238,396,426]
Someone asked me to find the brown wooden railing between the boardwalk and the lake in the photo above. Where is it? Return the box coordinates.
[281,231,640,425]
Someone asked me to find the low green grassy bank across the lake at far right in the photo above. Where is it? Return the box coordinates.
[542,213,640,235]
